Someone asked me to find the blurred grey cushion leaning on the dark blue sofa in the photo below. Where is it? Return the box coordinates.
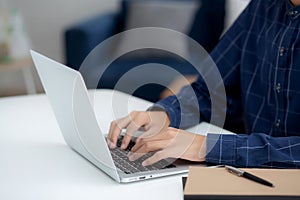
[117,0,200,58]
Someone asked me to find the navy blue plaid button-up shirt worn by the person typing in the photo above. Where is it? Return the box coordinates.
[156,0,300,168]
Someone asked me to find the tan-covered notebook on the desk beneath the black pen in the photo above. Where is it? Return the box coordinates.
[184,167,300,200]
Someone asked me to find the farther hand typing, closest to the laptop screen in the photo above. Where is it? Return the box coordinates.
[107,111,170,149]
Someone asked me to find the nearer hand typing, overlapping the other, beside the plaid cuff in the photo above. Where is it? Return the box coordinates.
[128,127,206,166]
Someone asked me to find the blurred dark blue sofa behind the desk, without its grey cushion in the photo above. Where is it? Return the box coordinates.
[65,0,225,102]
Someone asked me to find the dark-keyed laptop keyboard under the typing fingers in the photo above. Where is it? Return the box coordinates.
[110,136,175,174]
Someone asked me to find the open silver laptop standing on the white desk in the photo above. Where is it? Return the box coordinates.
[31,51,188,183]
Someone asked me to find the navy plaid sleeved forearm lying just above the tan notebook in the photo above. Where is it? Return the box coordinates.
[206,133,300,168]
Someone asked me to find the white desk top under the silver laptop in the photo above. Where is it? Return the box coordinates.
[0,90,188,200]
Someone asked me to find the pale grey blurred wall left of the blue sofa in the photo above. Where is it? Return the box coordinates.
[10,0,119,62]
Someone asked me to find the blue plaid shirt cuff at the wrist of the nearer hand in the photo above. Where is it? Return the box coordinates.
[206,134,236,166]
